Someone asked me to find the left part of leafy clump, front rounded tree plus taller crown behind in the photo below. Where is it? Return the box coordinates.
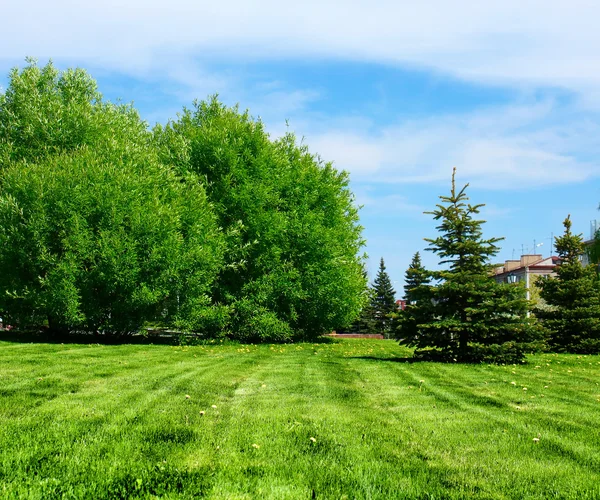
[0,61,223,334]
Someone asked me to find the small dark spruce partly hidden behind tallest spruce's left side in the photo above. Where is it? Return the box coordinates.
[395,252,431,345]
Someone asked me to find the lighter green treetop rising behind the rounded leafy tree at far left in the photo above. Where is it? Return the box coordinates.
[0,59,148,168]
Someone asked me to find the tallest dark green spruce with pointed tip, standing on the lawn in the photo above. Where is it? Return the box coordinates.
[412,169,538,362]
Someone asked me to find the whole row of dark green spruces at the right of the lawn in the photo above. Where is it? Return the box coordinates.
[356,169,600,363]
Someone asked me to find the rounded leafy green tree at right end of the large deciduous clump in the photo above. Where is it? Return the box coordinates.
[154,98,365,340]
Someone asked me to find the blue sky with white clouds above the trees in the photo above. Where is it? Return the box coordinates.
[0,0,600,296]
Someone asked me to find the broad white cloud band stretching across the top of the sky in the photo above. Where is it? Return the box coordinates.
[0,0,600,97]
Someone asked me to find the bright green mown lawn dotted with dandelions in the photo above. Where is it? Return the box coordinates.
[0,340,600,499]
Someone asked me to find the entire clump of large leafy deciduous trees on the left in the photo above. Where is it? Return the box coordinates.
[0,60,366,341]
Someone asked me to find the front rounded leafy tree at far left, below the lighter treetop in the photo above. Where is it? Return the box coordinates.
[0,149,222,334]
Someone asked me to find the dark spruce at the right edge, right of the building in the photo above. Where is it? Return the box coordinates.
[536,216,600,353]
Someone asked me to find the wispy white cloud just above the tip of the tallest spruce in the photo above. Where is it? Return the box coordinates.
[305,103,600,190]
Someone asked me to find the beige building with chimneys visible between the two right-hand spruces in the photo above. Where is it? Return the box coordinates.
[494,254,559,302]
